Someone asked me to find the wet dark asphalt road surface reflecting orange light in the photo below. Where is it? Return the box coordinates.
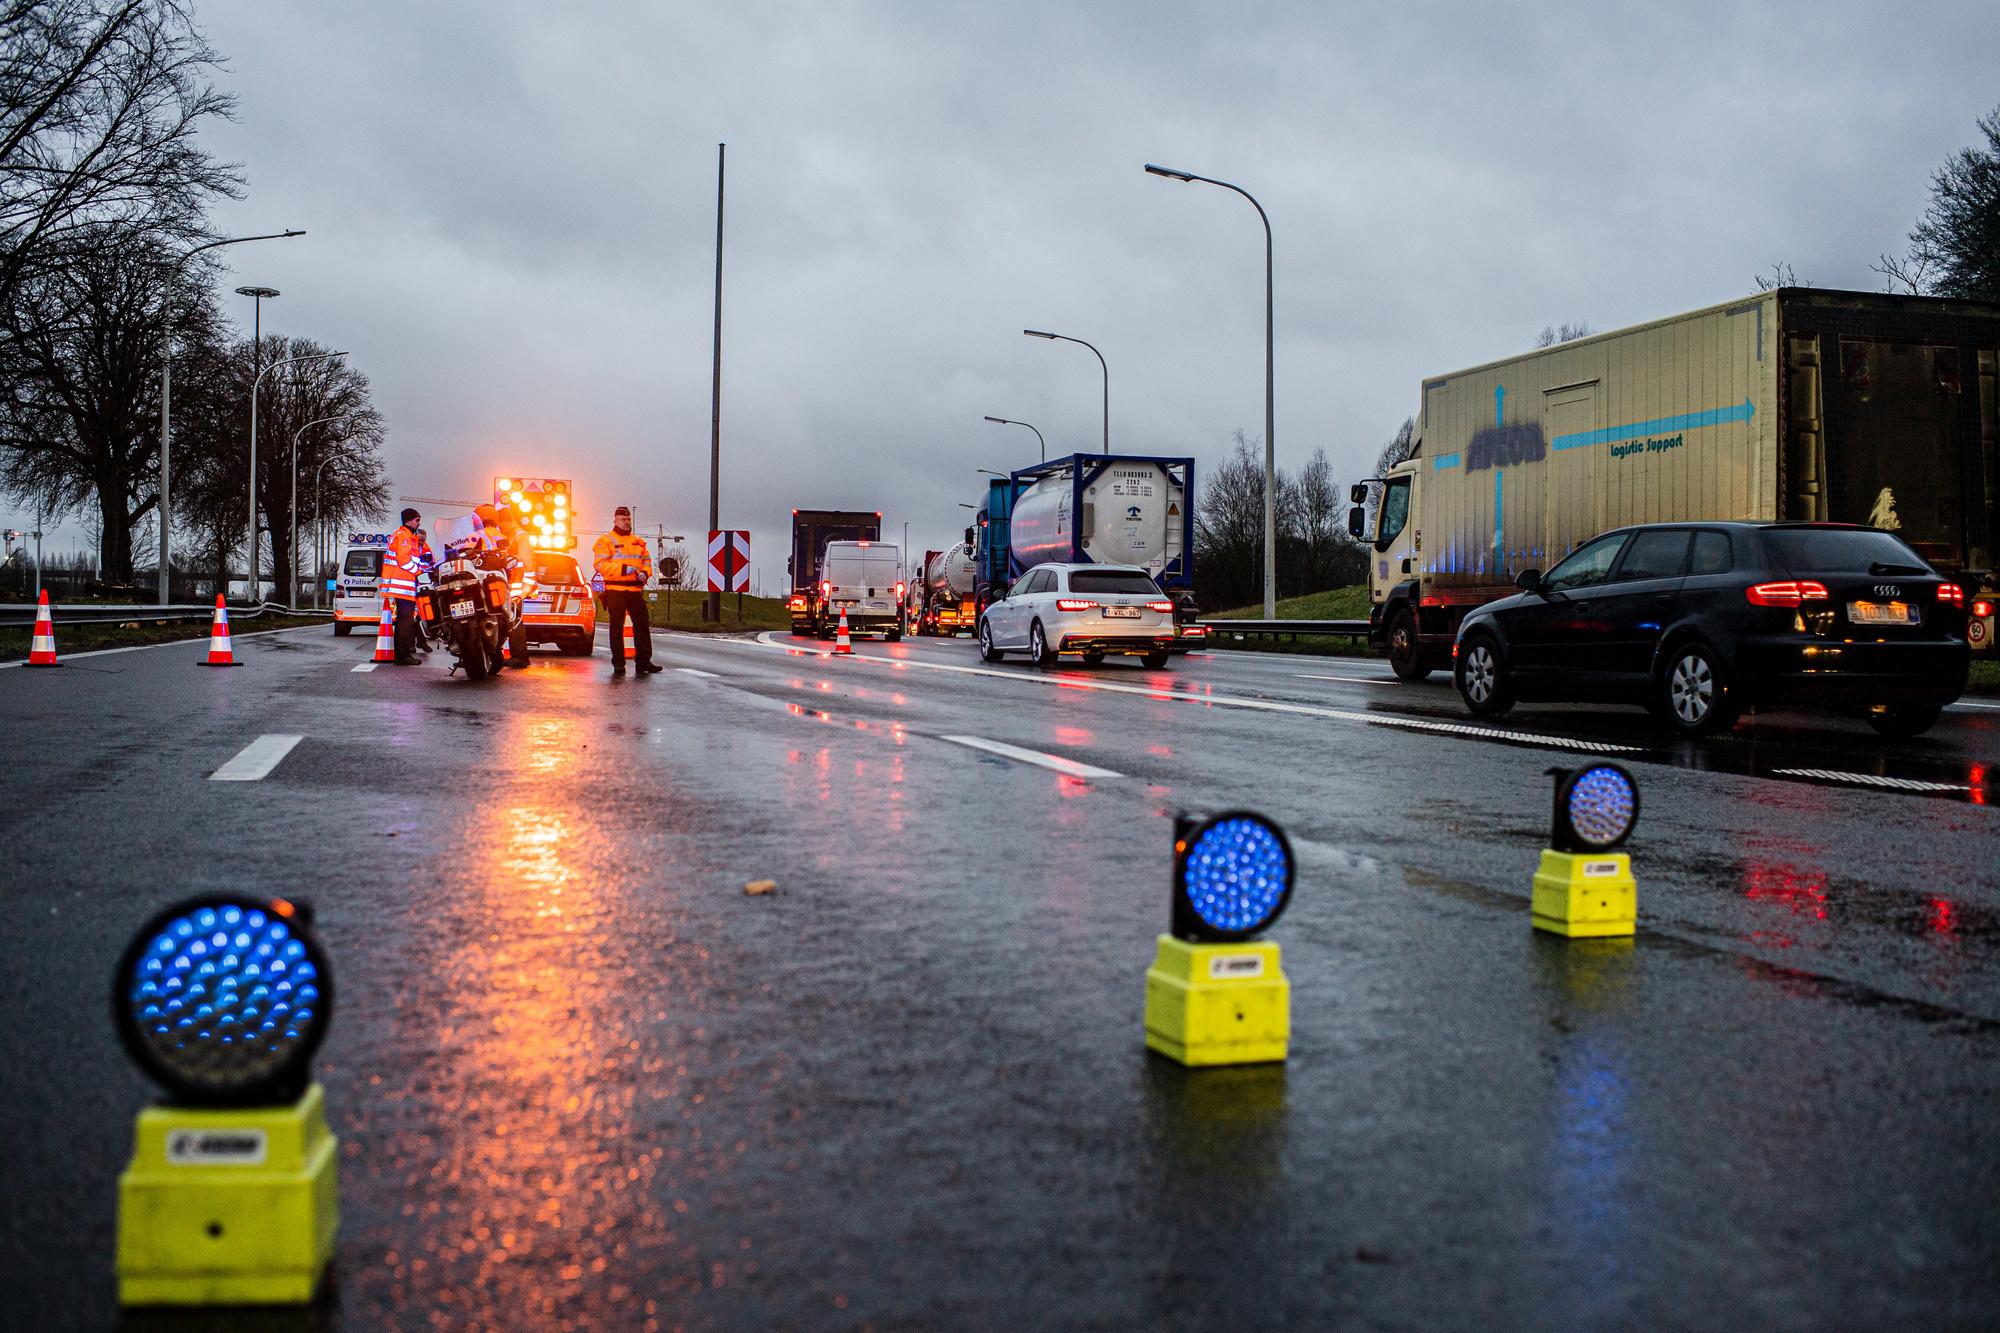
[0,630,2000,1329]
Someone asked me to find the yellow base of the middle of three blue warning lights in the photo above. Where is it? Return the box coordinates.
[1146,935,1292,1065]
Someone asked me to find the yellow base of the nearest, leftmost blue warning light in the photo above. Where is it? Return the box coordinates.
[118,1083,340,1305]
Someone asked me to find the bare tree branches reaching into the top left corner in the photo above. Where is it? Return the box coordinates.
[0,0,240,320]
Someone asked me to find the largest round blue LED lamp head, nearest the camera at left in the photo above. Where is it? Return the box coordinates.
[112,895,334,1107]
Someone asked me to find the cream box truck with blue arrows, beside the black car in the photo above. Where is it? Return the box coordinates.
[1348,288,2000,681]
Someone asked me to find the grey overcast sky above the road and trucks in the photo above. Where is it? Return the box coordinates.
[3,0,2000,592]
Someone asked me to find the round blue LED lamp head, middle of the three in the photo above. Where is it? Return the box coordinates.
[1174,811,1292,941]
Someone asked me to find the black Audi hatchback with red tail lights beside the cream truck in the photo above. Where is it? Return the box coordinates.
[1452,522,1970,737]
